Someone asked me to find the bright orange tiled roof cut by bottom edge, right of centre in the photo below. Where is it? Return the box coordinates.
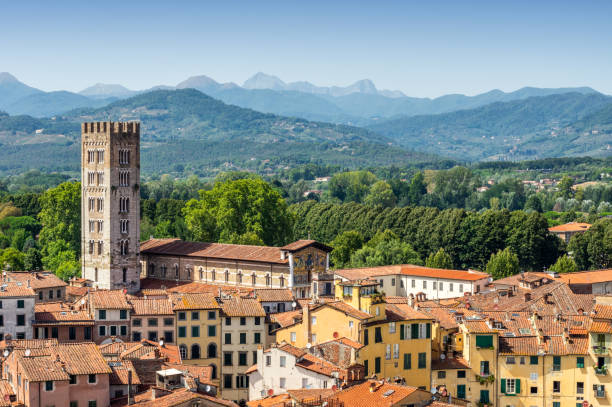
[333,380,430,407]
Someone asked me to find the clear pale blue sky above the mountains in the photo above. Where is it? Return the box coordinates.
[0,0,612,96]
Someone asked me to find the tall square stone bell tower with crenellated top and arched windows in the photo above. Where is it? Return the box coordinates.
[81,122,140,292]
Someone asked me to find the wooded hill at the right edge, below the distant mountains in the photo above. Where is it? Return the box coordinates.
[368,93,612,160]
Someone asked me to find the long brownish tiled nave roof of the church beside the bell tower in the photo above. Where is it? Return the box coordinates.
[140,239,289,264]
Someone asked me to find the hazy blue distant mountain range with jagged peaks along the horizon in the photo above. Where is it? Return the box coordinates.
[0,72,597,126]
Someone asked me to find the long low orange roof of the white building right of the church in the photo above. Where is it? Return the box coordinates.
[334,264,489,281]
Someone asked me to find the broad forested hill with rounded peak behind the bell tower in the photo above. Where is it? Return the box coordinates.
[0,89,436,175]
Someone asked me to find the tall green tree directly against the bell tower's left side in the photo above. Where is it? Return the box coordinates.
[38,182,81,257]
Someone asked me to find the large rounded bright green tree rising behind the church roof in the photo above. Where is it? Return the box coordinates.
[183,178,292,245]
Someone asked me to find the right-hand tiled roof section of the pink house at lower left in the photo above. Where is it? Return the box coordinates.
[52,343,111,375]
